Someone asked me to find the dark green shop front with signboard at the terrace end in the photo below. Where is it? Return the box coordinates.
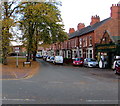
[96,43,120,68]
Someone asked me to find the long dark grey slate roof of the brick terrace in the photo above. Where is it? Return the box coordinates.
[68,18,111,39]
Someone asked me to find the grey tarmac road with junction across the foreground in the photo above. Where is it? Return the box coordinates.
[2,59,120,104]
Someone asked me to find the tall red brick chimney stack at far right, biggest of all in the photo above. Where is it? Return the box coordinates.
[111,3,120,19]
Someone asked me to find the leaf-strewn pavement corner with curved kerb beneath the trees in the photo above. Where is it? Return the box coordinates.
[1,62,39,80]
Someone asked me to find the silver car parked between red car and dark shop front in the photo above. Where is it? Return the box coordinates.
[84,58,98,67]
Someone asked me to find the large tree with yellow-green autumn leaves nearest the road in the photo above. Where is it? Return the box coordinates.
[2,0,67,61]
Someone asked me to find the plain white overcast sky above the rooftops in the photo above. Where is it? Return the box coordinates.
[60,0,120,32]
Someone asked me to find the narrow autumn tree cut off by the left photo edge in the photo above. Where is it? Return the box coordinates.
[0,0,18,65]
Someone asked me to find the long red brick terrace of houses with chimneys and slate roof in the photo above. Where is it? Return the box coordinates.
[41,4,120,66]
